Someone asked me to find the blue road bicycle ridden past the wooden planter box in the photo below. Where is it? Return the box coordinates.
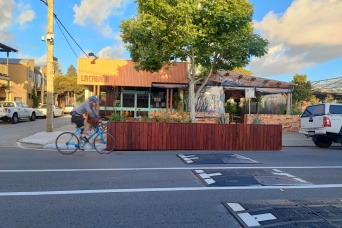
[55,123,115,155]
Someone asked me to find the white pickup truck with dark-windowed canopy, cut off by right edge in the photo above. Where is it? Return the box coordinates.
[299,103,342,148]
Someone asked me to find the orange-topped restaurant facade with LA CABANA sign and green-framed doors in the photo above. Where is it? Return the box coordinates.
[77,58,187,117]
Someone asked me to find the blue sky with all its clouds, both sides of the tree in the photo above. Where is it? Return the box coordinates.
[0,0,342,82]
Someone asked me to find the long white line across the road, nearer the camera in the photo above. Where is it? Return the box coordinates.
[0,184,342,197]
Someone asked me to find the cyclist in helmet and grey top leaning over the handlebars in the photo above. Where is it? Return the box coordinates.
[71,96,102,142]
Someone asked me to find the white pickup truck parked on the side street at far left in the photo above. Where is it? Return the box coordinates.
[0,101,36,124]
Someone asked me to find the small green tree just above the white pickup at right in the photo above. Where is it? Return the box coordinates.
[292,74,312,108]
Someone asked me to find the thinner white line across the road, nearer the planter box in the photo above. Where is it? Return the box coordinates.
[0,166,342,173]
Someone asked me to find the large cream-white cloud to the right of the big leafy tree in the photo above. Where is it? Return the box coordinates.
[250,0,342,76]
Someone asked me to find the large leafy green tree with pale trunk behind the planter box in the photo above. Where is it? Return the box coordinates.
[120,0,268,121]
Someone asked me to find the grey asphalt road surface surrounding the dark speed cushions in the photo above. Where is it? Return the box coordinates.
[0,118,342,228]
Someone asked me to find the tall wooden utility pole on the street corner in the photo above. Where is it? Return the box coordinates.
[43,0,54,132]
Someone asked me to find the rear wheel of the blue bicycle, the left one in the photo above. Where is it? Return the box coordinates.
[56,132,80,155]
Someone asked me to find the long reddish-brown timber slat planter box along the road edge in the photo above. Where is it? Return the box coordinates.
[107,122,282,150]
